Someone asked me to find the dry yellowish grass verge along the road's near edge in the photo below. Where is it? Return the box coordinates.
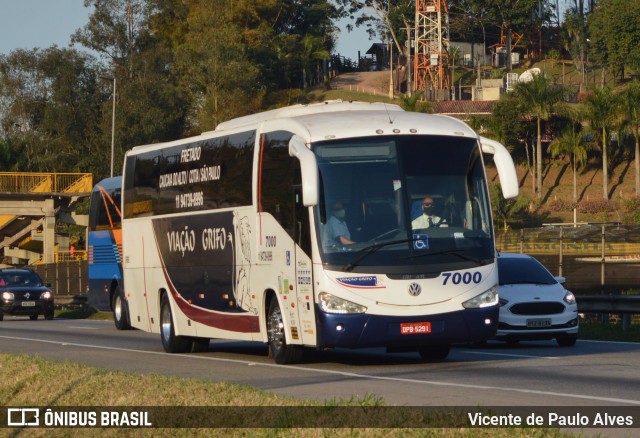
[0,354,571,437]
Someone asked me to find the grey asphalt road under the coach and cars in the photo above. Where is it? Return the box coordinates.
[0,317,640,407]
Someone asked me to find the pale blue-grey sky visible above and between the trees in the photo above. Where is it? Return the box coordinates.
[0,0,379,61]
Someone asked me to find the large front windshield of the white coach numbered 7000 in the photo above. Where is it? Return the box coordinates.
[312,135,495,276]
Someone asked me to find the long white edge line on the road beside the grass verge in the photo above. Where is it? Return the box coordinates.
[0,336,640,406]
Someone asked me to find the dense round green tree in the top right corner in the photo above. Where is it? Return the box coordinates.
[588,0,640,79]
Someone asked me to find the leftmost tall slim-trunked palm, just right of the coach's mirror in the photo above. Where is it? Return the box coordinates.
[513,73,565,198]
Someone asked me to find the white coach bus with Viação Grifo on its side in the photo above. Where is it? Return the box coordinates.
[122,102,518,363]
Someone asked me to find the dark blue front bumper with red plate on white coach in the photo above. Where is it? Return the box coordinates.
[317,306,499,349]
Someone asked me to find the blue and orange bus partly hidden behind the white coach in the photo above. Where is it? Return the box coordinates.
[87,176,130,330]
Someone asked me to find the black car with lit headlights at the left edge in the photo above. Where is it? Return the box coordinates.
[0,268,53,321]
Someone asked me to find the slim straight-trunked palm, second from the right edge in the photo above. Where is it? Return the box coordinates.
[582,87,617,199]
